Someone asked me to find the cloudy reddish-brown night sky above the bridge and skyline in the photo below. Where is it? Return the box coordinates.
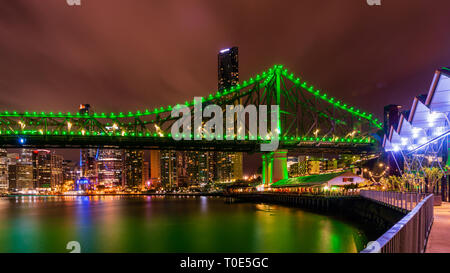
[0,0,450,172]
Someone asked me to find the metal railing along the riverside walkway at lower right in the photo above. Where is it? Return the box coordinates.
[361,191,434,253]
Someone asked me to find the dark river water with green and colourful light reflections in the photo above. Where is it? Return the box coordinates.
[0,196,367,253]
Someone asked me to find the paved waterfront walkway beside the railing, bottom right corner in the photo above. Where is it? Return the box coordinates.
[426,202,450,253]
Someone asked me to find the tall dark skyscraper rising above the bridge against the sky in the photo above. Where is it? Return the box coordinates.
[217,47,239,91]
